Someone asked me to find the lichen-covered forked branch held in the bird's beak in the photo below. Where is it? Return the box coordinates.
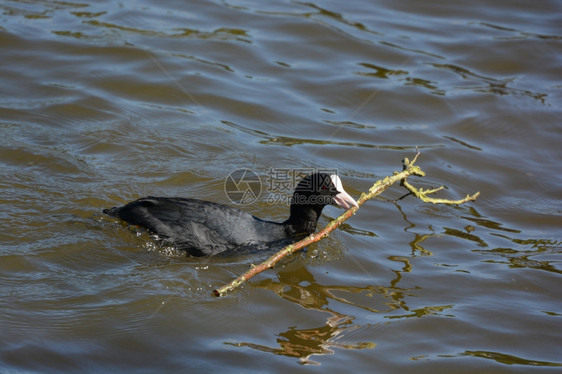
[213,151,479,297]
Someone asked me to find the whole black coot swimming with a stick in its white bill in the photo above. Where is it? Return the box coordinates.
[103,173,357,256]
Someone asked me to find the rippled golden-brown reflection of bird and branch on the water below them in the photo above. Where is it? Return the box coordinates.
[227,221,468,364]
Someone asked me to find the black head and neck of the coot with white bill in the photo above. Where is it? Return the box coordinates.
[286,173,358,233]
